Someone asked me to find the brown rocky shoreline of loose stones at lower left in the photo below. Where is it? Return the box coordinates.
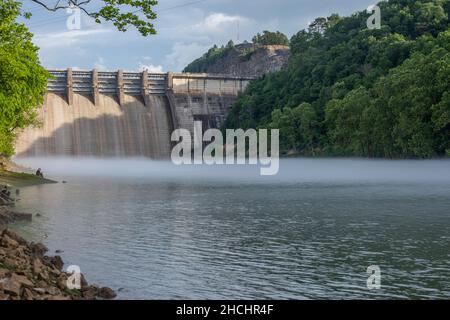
[0,206,116,300]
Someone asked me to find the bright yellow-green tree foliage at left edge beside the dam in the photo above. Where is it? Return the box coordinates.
[0,0,49,156]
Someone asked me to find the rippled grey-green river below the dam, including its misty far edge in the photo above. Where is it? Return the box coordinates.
[9,159,450,299]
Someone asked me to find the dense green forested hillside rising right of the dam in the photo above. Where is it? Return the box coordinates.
[225,0,450,158]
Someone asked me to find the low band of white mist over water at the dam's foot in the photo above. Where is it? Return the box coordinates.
[15,158,450,183]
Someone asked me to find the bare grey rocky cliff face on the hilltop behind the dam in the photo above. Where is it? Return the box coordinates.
[192,43,291,77]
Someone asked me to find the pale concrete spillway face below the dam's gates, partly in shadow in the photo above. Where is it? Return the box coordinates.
[16,93,172,159]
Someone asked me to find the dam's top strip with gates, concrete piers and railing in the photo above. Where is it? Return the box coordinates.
[47,68,256,105]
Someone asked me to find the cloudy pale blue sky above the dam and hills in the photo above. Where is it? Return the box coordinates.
[23,0,377,72]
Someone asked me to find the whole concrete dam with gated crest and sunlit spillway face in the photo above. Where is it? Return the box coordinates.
[16,69,253,159]
